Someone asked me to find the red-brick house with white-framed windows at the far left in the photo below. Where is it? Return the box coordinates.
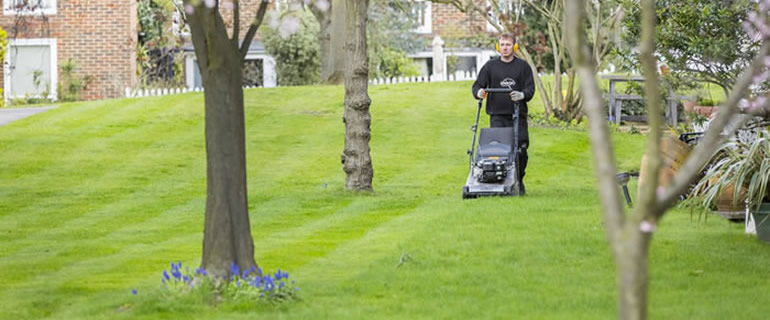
[0,0,137,100]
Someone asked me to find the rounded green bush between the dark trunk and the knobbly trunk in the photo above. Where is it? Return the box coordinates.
[261,10,321,86]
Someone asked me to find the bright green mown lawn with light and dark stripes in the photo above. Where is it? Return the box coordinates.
[0,82,770,319]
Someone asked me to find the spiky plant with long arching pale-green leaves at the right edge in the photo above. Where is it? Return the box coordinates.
[691,128,770,242]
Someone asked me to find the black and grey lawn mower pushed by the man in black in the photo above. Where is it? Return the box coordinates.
[463,88,520,199]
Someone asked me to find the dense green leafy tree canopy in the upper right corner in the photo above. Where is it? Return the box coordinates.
[621,0,759,92]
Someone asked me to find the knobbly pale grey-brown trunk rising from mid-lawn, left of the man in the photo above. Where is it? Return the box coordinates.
[342,0,374,191]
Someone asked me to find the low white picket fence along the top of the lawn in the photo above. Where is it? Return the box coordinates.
[124,71,476,98]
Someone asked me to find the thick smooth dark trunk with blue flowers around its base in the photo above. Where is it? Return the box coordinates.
[189,2,257,276]
